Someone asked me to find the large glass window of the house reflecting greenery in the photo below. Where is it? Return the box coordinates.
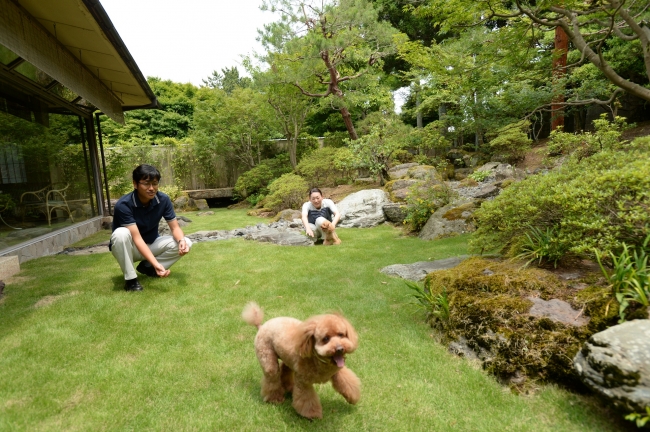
[0,112,96,250]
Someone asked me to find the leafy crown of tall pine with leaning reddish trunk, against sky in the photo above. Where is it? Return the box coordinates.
[261,0,397,139]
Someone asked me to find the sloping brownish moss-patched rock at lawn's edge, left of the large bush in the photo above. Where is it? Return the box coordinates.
[418,199,478,240]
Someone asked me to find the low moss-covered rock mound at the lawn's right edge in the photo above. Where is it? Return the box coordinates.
[418,257,616,390]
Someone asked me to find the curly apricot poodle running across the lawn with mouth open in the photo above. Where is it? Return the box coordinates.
[242,303,361,419]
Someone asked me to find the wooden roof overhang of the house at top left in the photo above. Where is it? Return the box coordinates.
[0,0,158,123]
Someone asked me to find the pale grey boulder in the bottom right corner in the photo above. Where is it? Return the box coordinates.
[573,320,650,412]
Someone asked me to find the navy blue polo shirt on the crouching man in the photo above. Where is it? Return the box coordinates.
[113,190,176,244]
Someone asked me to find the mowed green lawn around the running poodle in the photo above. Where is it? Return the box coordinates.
[0,210,624,431]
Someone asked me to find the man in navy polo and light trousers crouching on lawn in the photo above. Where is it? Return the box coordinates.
[109,164,192,291]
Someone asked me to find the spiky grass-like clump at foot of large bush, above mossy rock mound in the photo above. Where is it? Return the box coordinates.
[517,226,568,267]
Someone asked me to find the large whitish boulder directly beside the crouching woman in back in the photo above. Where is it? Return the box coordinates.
[336,189,390,228]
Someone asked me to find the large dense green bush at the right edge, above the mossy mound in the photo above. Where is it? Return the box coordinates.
[472,138,650,256]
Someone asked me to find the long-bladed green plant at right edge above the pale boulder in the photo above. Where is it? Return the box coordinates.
[595,234,650,323]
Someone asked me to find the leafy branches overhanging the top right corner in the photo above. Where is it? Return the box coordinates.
[419,0,650,103]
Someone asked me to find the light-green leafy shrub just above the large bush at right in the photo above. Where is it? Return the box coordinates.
[547,114,634,159]
